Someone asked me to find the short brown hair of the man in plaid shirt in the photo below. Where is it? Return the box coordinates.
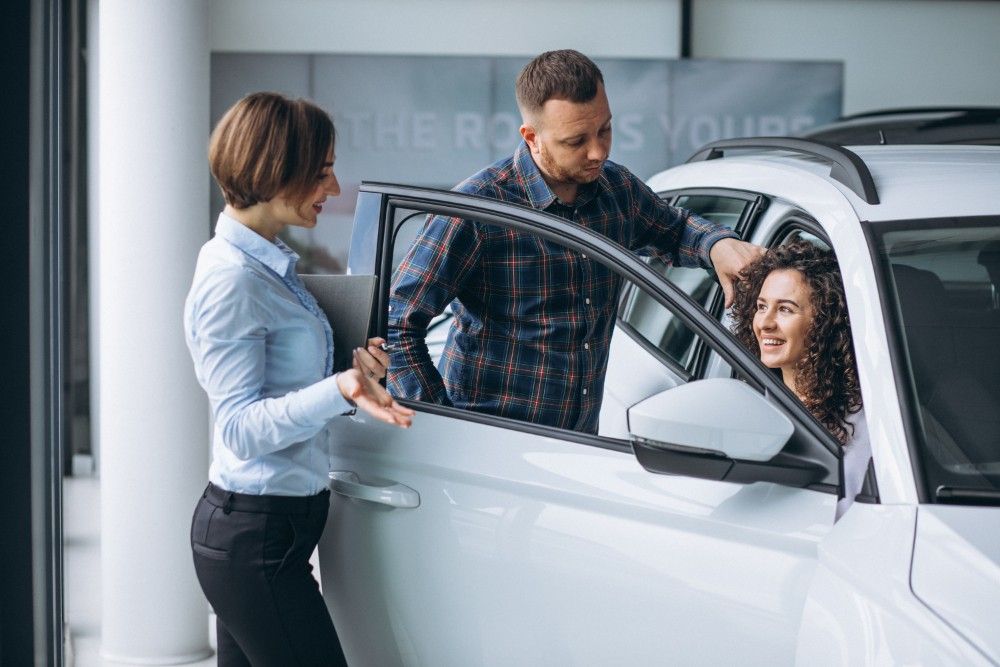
[516,49,604,116]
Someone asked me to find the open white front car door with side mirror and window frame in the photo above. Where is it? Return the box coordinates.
[320,184,839,667]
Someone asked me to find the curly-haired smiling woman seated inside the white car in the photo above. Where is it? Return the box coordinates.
[732,240,871,518]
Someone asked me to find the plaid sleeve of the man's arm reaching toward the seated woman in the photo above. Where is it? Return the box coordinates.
[629,174,739,269]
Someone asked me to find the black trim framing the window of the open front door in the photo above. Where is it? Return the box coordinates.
[360,182,840,492]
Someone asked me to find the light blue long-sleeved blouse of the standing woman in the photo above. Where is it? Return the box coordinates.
[184,214,352,496]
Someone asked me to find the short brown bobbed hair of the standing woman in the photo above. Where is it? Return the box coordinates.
[208,93,336,209]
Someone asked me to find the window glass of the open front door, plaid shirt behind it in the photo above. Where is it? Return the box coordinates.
[387,209,703,438]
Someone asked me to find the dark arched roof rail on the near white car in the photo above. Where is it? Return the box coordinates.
[687,137,879,204]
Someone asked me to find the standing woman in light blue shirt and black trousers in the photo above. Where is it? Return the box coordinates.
[184,93,413,666]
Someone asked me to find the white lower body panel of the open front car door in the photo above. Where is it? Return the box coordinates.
[320,412,836,667]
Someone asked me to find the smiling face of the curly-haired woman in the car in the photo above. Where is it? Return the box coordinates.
[753,269,815,380]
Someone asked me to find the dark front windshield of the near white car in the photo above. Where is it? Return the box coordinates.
[875,218,1000,504]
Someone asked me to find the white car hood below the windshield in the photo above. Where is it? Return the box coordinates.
[910,505,1000,662]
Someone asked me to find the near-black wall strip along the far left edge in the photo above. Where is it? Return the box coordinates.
[0,0,38,667]
